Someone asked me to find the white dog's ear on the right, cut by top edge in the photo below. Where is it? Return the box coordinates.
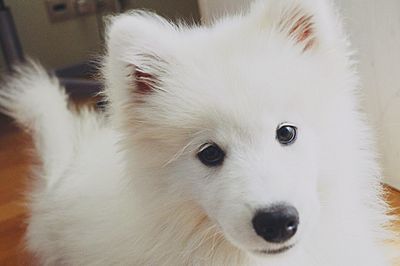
[251,0,340,51]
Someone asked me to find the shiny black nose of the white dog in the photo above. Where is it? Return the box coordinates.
[252,204,299,243]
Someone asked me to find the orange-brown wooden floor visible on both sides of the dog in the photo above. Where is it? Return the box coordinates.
[0,117,400,266]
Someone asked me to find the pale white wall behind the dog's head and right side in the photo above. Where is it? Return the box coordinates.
[199,0,400,189]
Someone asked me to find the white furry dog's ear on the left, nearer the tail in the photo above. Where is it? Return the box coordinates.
[103,11,177,105]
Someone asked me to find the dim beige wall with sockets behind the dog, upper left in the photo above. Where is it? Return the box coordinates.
[1,0,200,68]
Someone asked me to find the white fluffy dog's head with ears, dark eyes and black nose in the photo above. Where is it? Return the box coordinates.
[104,0,355,255]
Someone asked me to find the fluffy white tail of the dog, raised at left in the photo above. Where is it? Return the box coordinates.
[0,62,75,188]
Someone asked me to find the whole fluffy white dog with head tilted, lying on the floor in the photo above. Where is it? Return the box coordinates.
[0,0,394,266]
